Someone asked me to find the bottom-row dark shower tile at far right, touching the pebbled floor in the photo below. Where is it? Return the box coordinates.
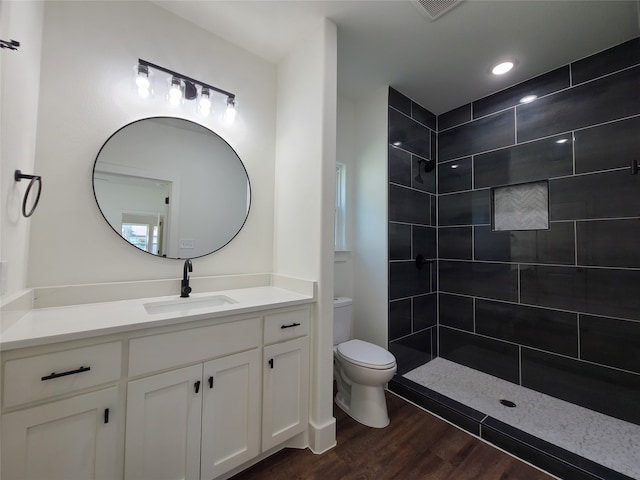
[522,348,640,423]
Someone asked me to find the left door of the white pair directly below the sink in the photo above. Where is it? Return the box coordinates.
[125,364,203,480]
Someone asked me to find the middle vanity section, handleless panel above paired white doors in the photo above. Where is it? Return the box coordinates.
[125,317,262,480]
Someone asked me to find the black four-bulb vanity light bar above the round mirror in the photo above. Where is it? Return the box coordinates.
[136,59,236,123]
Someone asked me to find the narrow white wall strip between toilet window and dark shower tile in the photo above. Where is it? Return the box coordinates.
[353,86,389,348]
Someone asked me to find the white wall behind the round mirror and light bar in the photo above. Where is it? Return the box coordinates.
[28,1,276,287]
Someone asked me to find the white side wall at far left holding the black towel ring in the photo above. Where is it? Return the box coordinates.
[0,1,47,297]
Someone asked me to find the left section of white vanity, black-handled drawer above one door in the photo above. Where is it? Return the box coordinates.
[2,342,124,480]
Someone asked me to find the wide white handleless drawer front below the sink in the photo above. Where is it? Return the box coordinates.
[129,318,262,377]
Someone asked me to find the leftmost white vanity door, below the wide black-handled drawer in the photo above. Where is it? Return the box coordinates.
[2,387,122,480]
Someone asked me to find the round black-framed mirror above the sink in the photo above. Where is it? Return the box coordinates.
[93,117,251,259]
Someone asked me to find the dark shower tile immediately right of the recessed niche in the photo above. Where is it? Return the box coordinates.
[549,170,640,220]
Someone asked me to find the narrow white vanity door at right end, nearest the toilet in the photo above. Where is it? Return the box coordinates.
[262,337,309,451]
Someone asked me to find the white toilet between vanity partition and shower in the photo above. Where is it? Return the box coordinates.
[333,297,396,428]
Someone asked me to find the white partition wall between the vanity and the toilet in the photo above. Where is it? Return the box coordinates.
[274,20,337,452]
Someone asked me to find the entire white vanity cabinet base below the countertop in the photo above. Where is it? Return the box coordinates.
[1,301,311,480]
